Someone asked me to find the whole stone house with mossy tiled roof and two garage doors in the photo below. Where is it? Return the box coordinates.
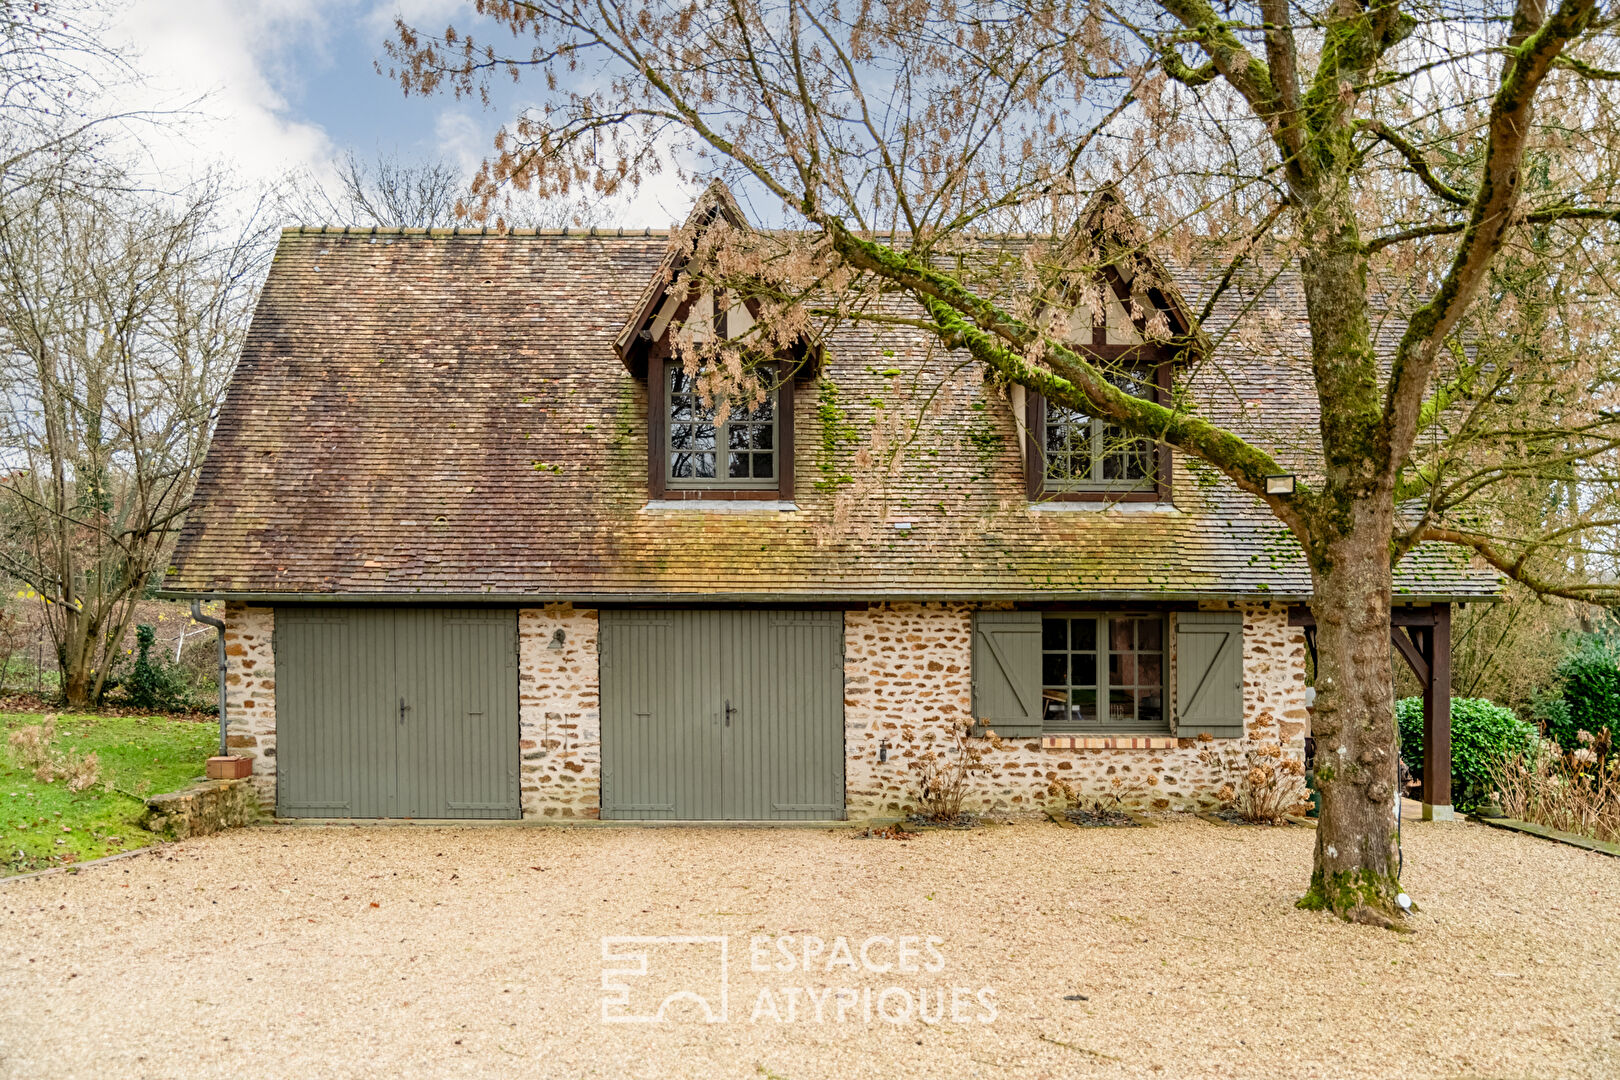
[165,189,1500,821]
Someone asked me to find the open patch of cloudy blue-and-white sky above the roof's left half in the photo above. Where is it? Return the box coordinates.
[113,0,692,225]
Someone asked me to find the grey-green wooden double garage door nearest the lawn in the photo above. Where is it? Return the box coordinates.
[275,607,518,818]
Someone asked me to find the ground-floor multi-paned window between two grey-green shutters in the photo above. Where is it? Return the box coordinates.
[1040,614,1170,733]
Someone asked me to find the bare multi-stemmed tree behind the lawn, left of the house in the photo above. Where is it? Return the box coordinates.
[0,173,269,706]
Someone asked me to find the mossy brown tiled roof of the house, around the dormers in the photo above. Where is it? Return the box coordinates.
[165,230,1497,602]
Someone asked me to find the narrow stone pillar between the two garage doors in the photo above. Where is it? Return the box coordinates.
[517,604,603,818]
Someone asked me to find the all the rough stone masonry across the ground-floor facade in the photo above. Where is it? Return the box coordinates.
[225,602,1307,819]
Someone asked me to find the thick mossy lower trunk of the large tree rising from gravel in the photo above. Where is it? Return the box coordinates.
[1299,500,1401,926]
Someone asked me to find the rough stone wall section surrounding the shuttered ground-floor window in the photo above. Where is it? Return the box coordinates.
[844,604,1306,819]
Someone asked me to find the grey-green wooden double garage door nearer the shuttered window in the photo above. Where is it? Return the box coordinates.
[601,610,844,821]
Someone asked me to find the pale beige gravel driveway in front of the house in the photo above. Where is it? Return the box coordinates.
[0,819,1620,1080]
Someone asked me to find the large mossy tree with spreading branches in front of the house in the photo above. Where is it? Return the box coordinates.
[387,0,1620,925]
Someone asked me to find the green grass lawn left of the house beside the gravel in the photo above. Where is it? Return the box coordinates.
[0,712,219,876]
